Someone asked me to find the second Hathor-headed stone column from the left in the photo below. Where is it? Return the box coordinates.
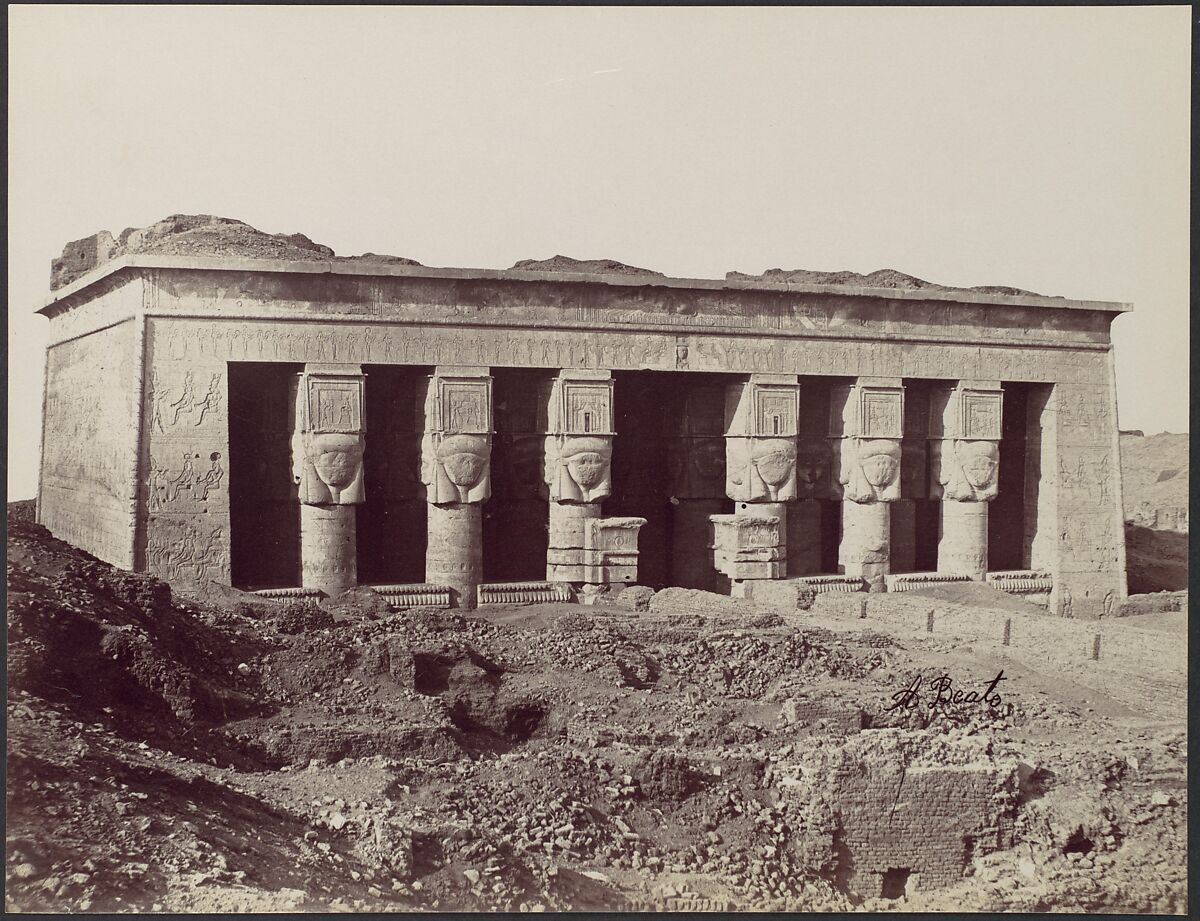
[421,366,492,608]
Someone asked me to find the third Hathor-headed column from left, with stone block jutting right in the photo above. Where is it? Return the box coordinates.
[542,369,646,602]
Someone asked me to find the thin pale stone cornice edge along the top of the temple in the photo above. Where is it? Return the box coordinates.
[37,253,1133,317]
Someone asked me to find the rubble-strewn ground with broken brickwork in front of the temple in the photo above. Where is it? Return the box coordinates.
[6,517,1187,911]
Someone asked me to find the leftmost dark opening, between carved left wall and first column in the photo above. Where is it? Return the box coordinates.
[229,361,304,589]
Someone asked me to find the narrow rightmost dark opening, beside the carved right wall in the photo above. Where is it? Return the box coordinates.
[988,381,1032,571]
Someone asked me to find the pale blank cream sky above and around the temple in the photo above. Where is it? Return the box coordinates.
[8,6,1192,499]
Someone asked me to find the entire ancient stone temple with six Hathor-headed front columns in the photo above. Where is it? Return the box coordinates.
[38,217,1129,618]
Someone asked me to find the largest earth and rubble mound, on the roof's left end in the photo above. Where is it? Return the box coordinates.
[50,215,420,290]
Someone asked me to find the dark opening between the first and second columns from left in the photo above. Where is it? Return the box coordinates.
[356,365,430,585]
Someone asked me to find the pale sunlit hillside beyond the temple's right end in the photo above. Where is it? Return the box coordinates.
[1121,432,1190,531]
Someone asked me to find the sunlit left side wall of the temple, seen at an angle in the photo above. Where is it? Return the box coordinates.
[37,291,140,568]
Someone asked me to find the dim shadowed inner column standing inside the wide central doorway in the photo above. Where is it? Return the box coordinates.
[667,385,728,591]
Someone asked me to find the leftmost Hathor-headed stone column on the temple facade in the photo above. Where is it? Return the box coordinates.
[292,365,365,596]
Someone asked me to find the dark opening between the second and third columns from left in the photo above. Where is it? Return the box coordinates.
[484,368,552,582]
